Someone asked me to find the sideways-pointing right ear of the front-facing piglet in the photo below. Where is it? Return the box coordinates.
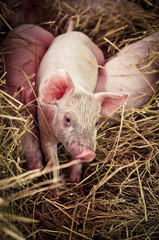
[95,92,128,115]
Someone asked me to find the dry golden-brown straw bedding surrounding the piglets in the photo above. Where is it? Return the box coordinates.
[0,0,159,240]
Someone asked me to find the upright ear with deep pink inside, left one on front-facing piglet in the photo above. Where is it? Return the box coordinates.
[39,69,74,104]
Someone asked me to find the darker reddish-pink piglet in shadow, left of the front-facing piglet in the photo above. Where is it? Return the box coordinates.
[3,24,53,170]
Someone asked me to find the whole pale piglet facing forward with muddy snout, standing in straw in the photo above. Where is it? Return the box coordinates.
[38,31,127,183]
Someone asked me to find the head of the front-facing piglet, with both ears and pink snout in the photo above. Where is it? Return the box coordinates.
[39,70,127,165]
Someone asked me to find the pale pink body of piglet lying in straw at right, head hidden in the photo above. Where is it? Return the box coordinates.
[95,32,159,109]
